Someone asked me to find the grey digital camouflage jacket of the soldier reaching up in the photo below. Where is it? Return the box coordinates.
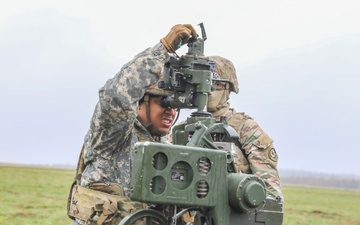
[74,43,170,225]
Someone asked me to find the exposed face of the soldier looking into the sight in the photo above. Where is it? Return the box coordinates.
[139,96,177,134]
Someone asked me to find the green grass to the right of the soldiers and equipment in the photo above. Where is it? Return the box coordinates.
[283,185,360,225]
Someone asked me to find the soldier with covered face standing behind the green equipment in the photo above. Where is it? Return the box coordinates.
[207,56,283,201]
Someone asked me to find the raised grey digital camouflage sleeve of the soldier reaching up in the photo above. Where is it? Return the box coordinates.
[85,43,169,161]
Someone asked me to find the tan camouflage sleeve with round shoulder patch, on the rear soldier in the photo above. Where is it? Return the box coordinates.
[240,118,283,198]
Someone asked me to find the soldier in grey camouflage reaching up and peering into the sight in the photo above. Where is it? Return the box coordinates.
[68,24,197,225]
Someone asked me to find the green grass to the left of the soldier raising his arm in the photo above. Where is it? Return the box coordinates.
[0,166,74,225]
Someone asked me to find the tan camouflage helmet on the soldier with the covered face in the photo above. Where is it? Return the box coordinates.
[209,56,239,94]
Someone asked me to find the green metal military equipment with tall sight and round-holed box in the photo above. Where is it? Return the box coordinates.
[119,23,283,225]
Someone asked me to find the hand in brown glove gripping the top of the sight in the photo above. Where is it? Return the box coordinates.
[160,24,197,53]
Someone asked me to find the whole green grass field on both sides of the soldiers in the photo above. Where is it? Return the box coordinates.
[0,166,360,225]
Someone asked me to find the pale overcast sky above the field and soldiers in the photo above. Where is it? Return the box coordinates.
[0,0,360,175]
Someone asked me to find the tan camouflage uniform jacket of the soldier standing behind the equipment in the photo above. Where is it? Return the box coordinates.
[224,108,283,200]
